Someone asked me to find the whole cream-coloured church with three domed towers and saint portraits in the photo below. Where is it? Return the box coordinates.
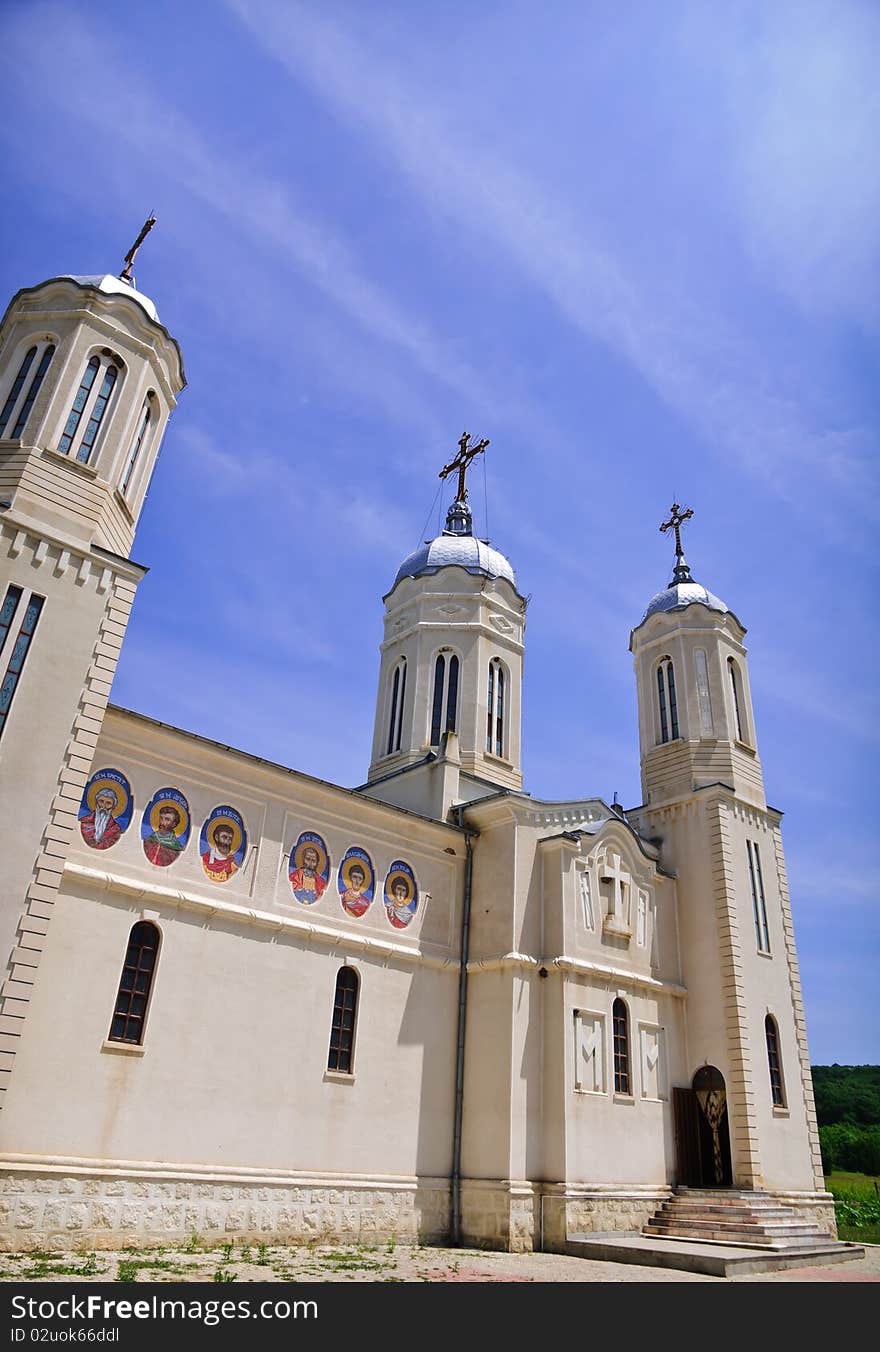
[0,255,834,1249]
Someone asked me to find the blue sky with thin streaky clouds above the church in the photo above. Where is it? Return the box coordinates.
[0,0,880,1063]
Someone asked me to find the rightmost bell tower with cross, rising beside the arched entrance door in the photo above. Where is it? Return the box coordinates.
[627,503,825,1197]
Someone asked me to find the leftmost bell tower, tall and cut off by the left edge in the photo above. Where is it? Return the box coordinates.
[0,222,185,1101]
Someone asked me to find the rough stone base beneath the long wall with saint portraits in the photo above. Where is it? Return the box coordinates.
[0,1160,451,1252]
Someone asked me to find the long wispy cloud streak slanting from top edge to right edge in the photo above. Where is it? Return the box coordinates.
[226,0,873,545]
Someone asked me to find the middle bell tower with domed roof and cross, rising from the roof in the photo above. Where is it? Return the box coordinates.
[364,433,526,817]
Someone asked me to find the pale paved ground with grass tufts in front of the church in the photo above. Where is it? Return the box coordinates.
[0,1240,880,1284]
